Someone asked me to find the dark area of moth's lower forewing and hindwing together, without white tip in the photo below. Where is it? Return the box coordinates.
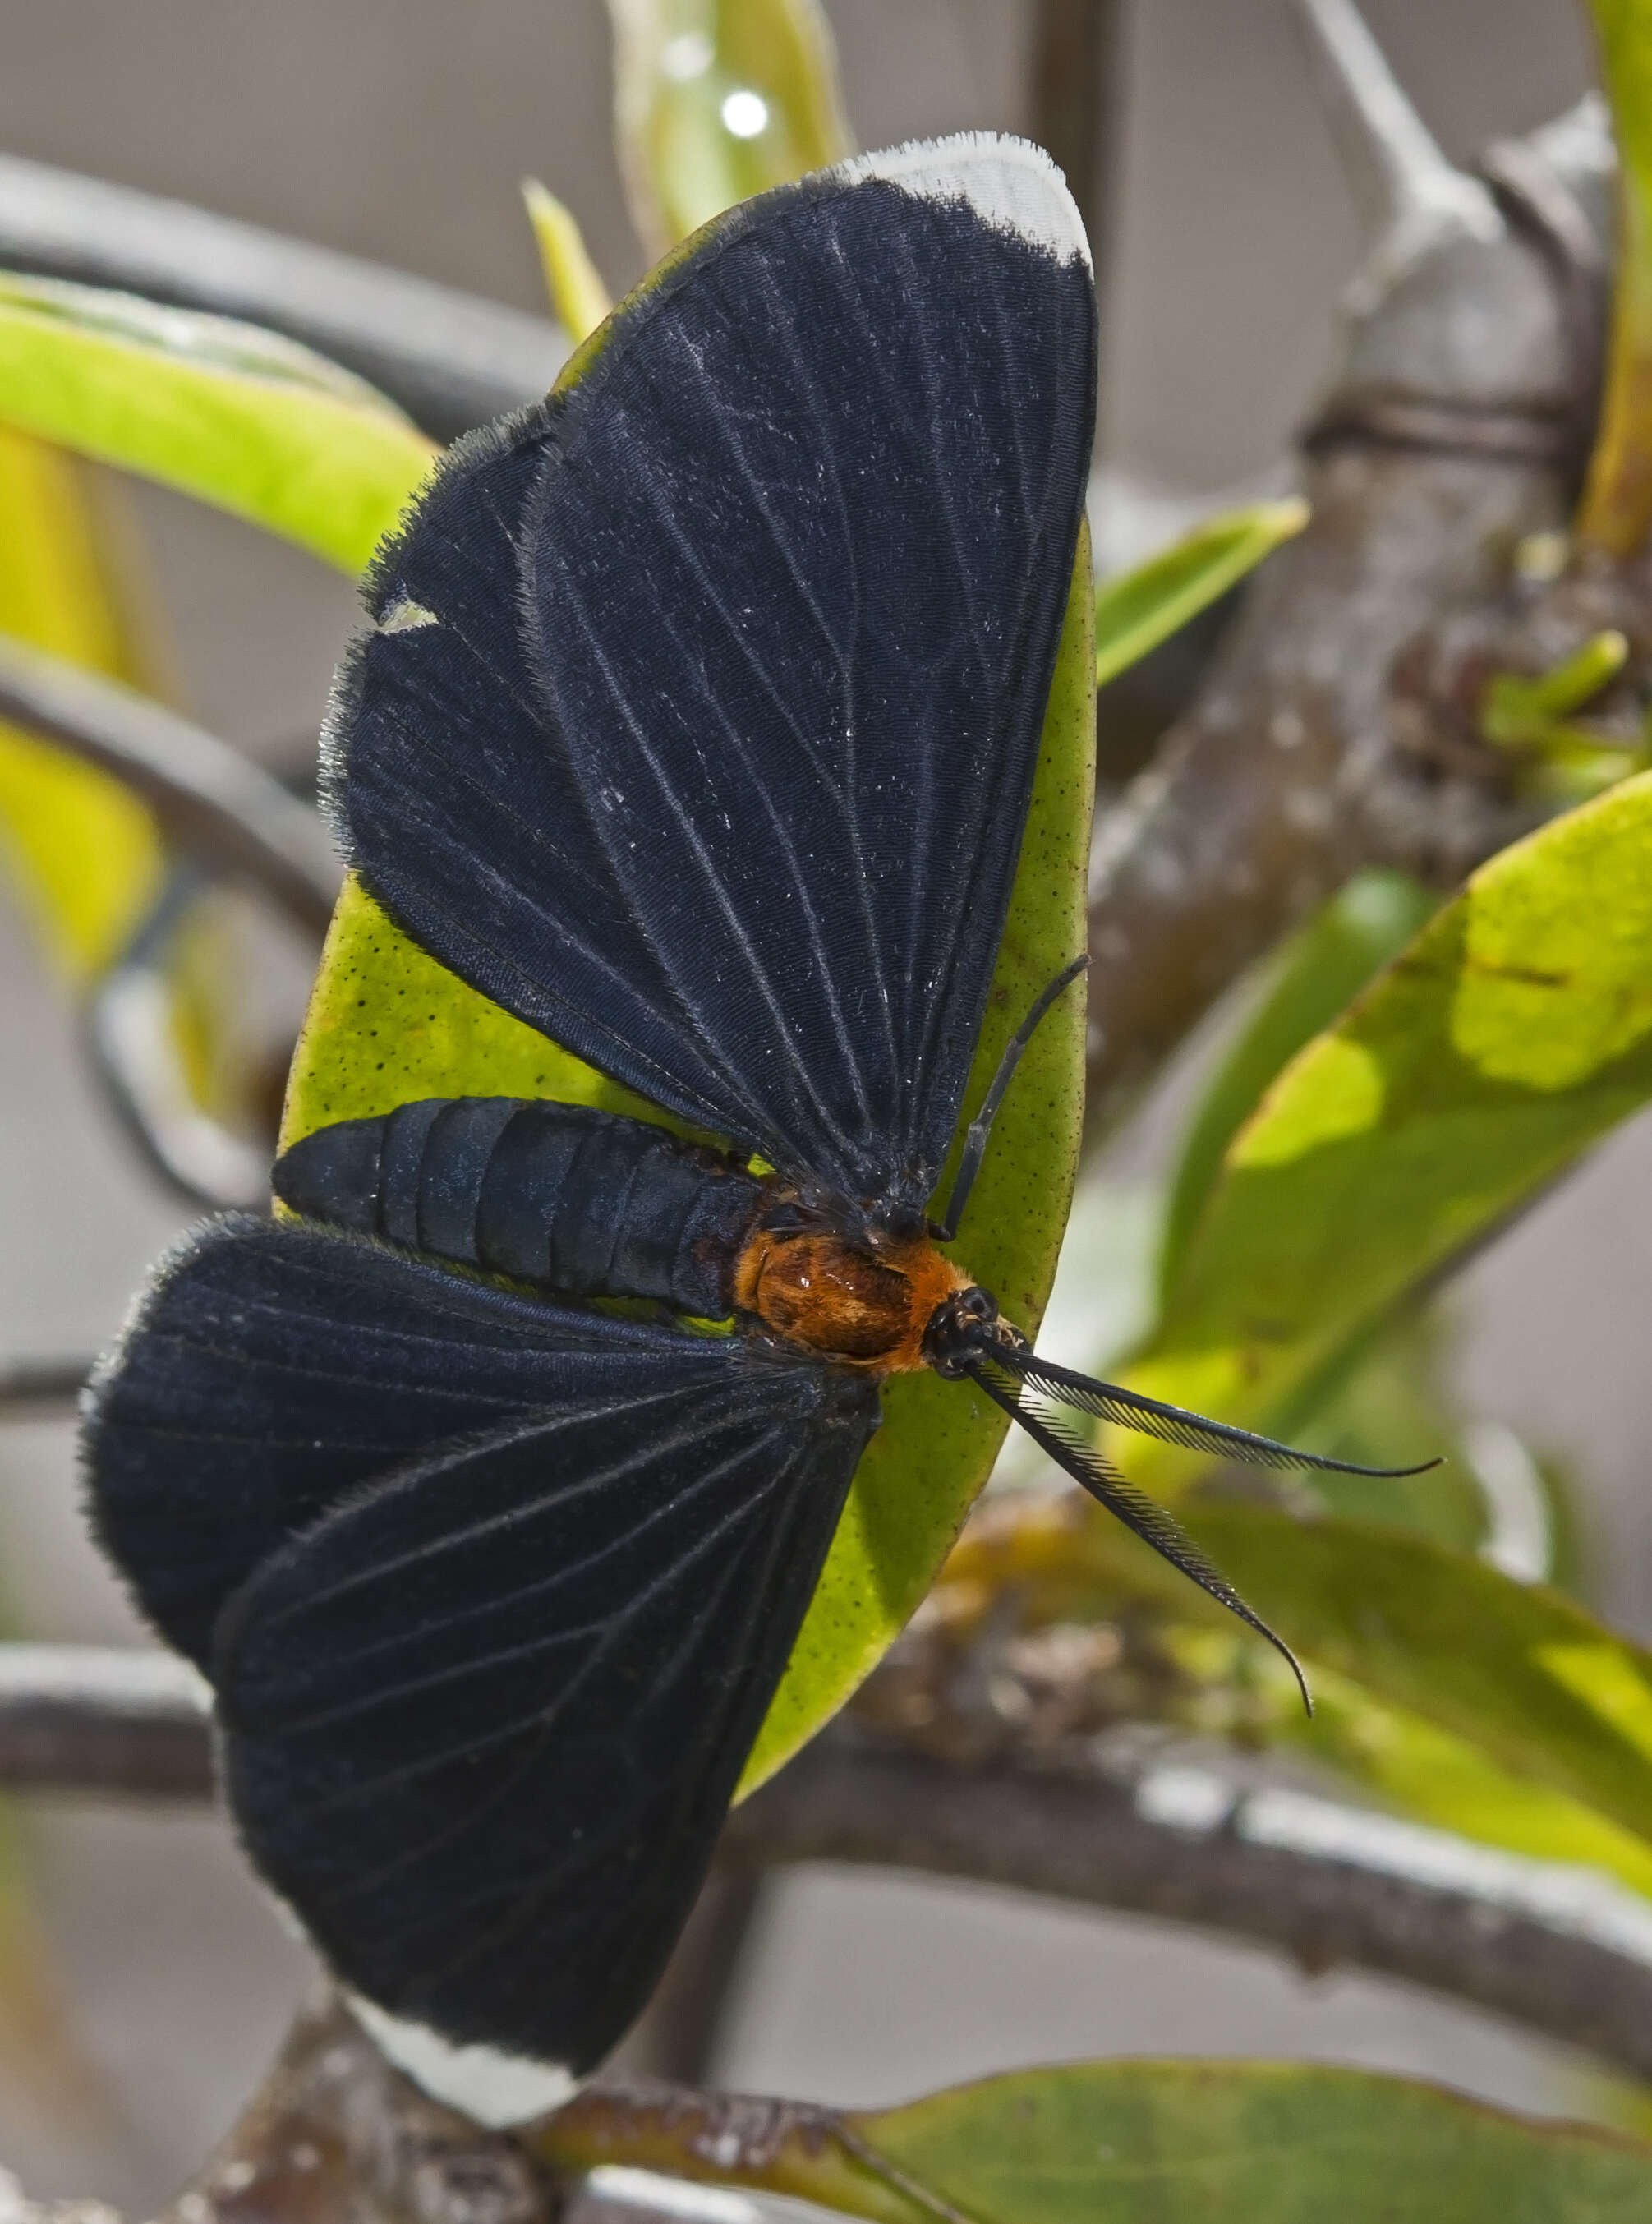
[87,1217,878,2069]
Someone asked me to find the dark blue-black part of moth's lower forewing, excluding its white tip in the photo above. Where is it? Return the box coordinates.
[214,1370,867,2073]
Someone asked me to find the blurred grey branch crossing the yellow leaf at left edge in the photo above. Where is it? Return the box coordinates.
[0,636,343,934]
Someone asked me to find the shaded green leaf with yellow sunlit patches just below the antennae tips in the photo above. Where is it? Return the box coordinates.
[943,1492,1652,1890]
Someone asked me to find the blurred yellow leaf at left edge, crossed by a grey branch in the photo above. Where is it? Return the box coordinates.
[0,425,160,981]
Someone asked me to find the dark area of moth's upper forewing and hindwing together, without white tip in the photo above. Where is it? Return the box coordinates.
[331,148,1094,1208]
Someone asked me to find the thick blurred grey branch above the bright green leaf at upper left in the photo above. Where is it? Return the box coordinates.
[0,155,567,440]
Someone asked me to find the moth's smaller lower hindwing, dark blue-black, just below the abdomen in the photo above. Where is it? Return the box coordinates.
[85,1214,840,1668]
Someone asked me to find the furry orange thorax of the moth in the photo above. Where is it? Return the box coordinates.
[734,1227,969,1374]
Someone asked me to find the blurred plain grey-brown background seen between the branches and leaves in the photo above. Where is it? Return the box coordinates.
[0,0,1652,2206]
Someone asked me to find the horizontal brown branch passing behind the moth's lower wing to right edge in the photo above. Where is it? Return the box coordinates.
[0,1646,1652,2075]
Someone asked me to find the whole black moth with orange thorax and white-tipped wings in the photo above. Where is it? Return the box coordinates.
[87,136,1432,2121]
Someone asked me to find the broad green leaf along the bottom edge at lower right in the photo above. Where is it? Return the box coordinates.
[847,2061,1652,2224]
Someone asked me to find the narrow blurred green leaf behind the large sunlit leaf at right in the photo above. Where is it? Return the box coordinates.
[1158,872,1438,1303]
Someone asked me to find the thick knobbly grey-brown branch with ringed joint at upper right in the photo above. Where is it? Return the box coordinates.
[1089,82,1610,1117]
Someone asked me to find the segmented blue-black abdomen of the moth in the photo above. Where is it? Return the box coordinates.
[274,1097,765,1319]
